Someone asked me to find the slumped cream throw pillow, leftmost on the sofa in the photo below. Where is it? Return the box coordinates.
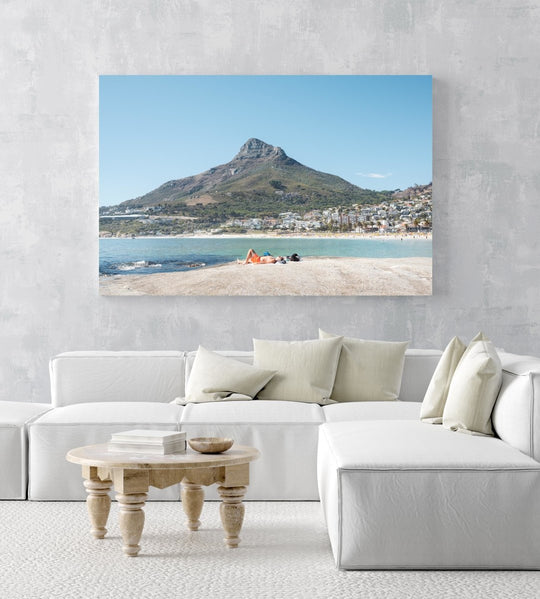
[176,345,275,404]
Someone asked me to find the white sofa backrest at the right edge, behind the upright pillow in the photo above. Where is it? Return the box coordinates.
[491,352,540,461]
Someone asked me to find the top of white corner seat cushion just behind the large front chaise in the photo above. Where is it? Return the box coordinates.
[323,400,421,422]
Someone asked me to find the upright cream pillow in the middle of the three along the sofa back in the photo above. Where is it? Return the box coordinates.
[253,337,342,405]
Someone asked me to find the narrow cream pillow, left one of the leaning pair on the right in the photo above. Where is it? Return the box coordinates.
[420,337,467,424]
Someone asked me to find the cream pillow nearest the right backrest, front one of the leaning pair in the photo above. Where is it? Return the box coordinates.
[443,333,502,435]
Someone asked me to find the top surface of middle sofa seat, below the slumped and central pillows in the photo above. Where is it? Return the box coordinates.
[181,399,324,424]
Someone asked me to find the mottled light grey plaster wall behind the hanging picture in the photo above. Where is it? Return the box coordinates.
[0,0,540,401]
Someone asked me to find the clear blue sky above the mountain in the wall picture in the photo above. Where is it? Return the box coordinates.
[99,75,432,206]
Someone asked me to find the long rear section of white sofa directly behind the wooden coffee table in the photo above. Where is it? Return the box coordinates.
[23,350,441,500]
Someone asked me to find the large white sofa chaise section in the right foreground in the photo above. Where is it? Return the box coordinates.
[317,420,540,569]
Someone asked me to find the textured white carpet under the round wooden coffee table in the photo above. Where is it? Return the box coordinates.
[0,502,540,599]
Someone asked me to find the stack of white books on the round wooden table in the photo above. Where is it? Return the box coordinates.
[108,430,186,455]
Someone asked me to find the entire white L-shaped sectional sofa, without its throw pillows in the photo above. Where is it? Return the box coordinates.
[0,350,540,569]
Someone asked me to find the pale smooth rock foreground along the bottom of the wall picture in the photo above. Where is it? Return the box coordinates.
[99,258,432,296]
